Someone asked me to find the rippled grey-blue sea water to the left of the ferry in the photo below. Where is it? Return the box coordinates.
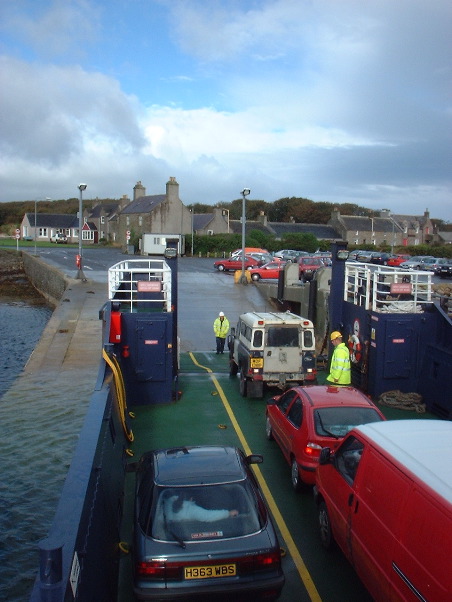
[0,301,55,602]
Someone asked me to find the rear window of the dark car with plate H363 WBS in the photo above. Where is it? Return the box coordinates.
[146,481,265,541]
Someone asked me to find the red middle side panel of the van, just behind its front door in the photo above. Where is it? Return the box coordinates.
[351,446,410,600]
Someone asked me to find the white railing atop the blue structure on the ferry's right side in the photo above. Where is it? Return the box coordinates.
[344,262,433,313]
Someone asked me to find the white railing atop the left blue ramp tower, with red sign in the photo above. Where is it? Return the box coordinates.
[108,258,172,312]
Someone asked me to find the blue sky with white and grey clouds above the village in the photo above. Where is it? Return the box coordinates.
[0,0,452,221]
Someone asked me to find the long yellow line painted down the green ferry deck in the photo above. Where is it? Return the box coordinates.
[189,351,322,602]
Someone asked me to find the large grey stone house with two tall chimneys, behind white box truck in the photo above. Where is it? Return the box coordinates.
[116,177,192,242]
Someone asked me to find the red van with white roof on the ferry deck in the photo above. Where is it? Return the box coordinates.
[314,419,452,602]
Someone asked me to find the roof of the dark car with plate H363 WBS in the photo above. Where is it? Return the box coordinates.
[150,446,246,486]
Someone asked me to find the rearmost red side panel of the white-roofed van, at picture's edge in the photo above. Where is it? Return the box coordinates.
[392,484,452,602]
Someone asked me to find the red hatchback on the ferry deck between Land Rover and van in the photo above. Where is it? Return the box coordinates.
[265,385,385,491]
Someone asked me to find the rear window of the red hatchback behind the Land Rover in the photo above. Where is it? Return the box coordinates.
[314,406,381,437]
